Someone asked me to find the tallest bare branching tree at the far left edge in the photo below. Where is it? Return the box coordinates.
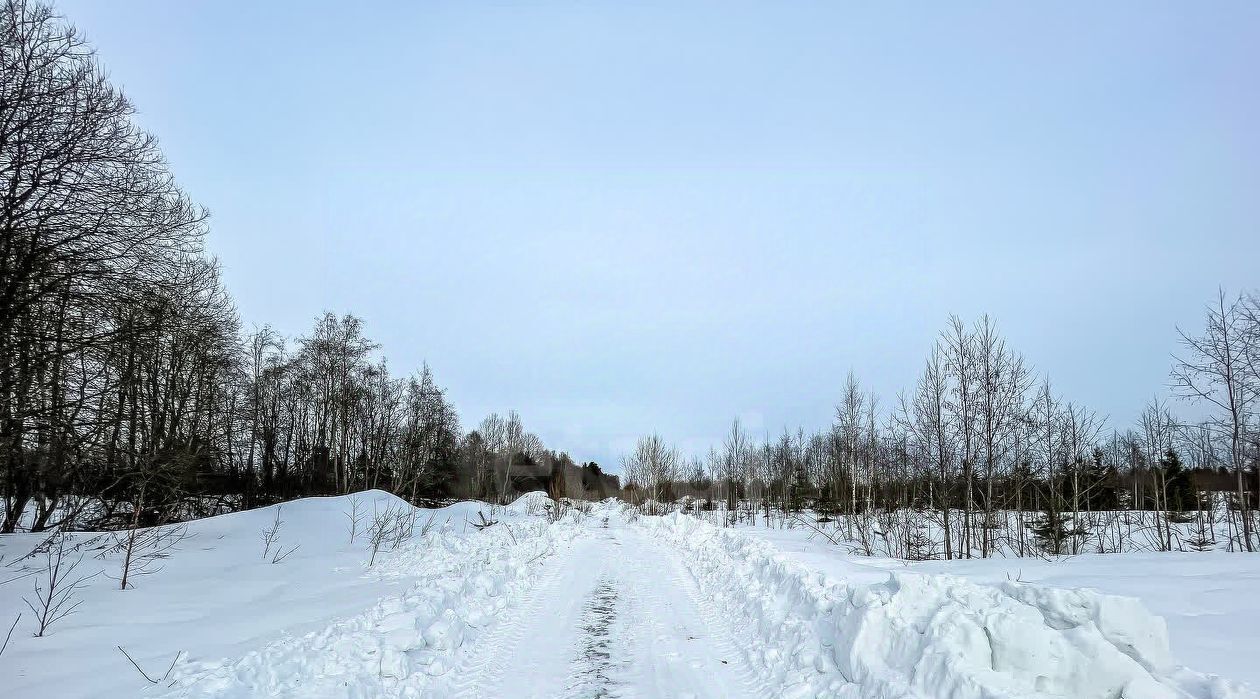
[0,0,205,533]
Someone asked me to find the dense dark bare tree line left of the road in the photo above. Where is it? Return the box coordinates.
[0,0,617,533]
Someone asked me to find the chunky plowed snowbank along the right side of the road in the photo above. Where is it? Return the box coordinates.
[643,514,1260,699]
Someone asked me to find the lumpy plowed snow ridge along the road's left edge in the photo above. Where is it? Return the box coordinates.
[158,504,581,699]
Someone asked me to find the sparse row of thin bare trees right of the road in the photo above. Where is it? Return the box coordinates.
[622,291,1260,559]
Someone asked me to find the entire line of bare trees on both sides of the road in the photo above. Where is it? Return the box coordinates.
[0,0,1260,558]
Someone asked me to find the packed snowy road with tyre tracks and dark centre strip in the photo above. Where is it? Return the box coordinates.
[457,523,760,699]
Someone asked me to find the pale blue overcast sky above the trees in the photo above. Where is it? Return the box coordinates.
[57,0,1260,465]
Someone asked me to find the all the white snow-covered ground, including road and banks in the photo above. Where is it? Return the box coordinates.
[0,492,1260,699]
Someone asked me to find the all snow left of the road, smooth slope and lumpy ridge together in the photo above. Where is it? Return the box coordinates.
[0,491,575,699]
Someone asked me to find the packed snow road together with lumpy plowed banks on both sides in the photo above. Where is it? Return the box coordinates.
[132,497,1260,699]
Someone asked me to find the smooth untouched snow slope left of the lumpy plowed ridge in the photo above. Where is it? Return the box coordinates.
[0,491,420,699]
